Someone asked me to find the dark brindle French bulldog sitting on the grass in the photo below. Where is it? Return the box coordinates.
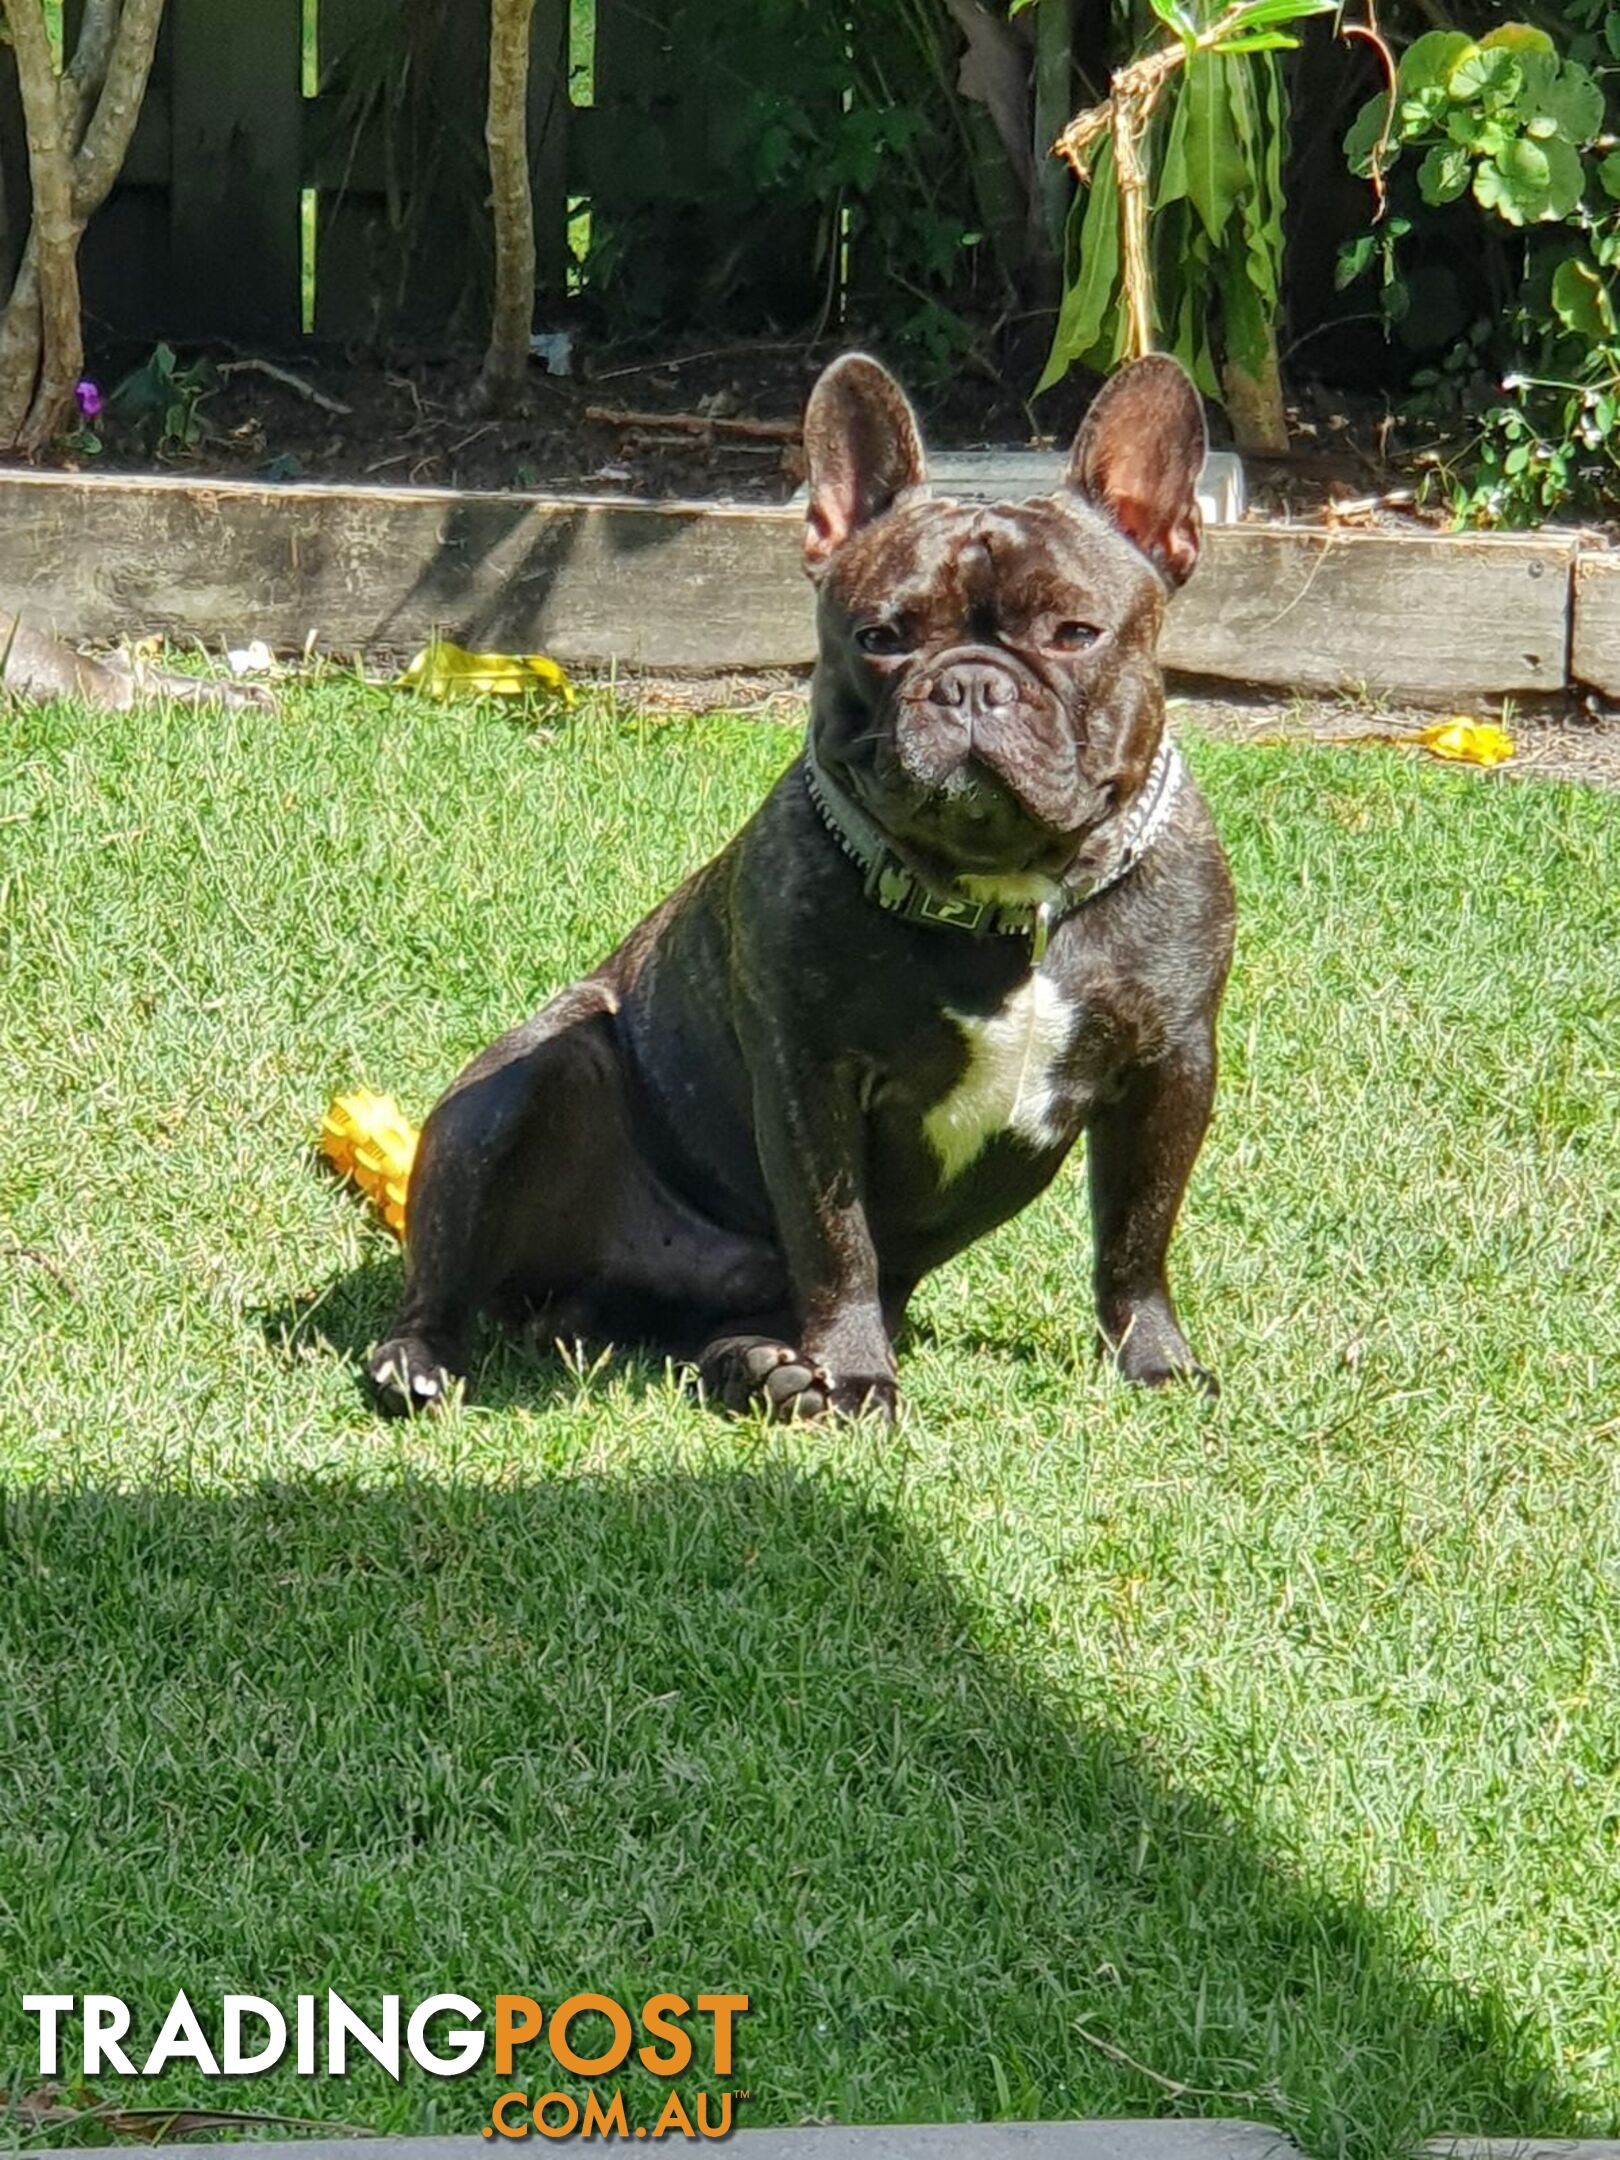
[372,354,1233,1415]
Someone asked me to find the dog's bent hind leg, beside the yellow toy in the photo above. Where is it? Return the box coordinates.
[369,981,626,1413]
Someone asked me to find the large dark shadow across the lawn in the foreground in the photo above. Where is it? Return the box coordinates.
[0,1462,1570,2160]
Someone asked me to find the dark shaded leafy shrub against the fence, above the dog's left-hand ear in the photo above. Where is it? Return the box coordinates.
[585,0,1002,382]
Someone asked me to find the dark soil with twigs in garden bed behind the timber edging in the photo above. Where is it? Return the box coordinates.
[19,339,1537,544]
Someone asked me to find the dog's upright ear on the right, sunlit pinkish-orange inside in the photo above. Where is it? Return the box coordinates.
[1067,352,1207,585]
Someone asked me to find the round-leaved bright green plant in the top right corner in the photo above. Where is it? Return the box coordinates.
[1339,15,1620,525]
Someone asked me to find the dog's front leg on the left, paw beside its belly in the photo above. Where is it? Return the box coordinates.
[700,1056,894,1419]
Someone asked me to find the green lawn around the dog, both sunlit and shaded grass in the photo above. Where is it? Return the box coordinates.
[0,685,1620,2160]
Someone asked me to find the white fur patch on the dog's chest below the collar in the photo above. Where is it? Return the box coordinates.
[922,972,1076,1184]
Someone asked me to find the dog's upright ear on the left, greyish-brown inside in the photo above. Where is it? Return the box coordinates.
[804,352,924,577]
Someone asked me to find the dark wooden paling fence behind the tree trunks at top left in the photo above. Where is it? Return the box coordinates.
[0,0,825,350]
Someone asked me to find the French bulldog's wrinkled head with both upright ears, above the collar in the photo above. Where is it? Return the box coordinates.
[806,354,1205,890]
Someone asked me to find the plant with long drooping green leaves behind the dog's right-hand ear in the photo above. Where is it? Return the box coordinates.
[1041,0,1331,447]
